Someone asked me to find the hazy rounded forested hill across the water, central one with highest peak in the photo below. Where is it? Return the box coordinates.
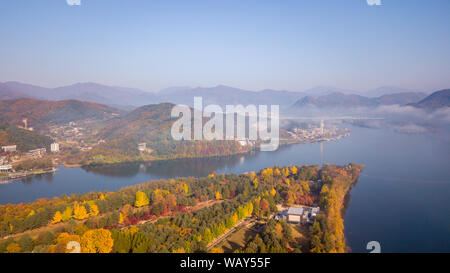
[79,103,250,165]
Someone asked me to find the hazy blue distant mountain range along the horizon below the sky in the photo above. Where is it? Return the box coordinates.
[0,82,425,110]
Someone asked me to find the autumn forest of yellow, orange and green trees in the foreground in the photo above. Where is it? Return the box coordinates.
[0,164,363,253]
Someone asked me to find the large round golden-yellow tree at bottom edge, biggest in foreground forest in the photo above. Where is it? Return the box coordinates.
[81,229,114,253]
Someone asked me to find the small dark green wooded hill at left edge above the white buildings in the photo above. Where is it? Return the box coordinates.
[0,121,52,152]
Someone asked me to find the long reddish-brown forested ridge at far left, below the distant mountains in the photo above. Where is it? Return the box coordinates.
[0,98,122,128]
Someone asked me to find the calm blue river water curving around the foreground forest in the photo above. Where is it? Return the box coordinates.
[0,127,450,252]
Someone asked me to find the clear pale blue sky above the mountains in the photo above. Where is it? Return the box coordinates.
[0,0,450,91]
